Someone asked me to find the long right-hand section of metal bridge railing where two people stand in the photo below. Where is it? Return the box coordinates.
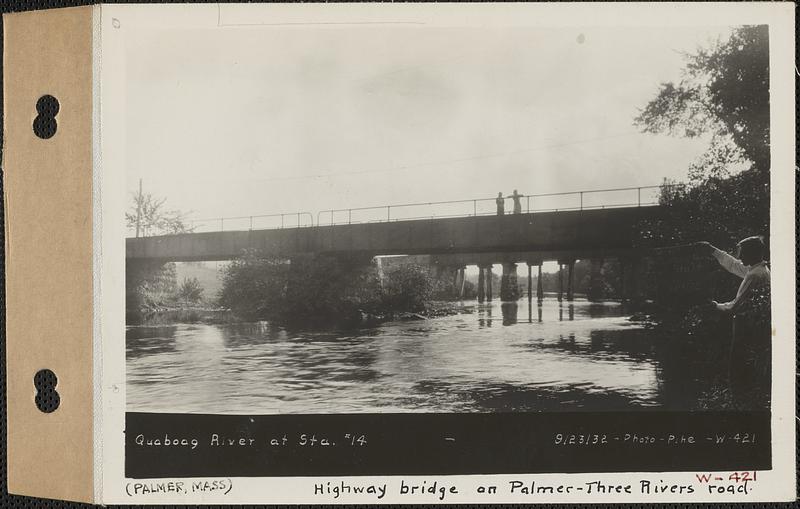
[316,184,682,226]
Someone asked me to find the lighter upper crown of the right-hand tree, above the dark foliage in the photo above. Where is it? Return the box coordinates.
[634,25,770,177]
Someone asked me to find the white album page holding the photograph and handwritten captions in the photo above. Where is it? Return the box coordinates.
[94,3,795,504]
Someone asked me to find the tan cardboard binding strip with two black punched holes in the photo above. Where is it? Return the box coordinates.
[3,6,95,502]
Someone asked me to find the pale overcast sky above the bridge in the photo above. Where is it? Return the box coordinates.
[125,26,730,226]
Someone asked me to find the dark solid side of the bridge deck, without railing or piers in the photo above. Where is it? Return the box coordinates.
[125,206,661,261]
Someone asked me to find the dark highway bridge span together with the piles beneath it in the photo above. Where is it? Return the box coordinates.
[126,188,662,300]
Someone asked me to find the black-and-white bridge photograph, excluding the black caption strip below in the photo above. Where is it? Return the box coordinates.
[128,19,771,414]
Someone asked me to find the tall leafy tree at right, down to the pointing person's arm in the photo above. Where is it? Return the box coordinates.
[634,25,770,247]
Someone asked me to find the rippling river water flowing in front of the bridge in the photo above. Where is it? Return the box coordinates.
[126,299,715,414]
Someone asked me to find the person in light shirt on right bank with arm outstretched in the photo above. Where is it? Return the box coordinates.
[697,237,772,406]
